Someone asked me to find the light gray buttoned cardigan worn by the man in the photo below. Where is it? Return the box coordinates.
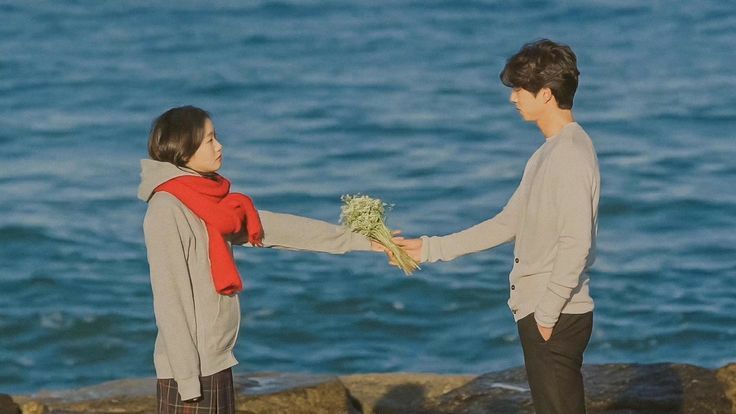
[421,122,600,327]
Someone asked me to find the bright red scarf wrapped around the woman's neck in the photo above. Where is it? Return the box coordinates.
[154,175,263,295]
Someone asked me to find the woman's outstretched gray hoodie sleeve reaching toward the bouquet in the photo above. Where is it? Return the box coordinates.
[234,210,371,254]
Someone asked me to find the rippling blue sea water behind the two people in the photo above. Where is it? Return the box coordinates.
[0,0,736,393]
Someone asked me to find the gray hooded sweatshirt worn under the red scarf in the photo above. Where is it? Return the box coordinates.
[138,160,371,400]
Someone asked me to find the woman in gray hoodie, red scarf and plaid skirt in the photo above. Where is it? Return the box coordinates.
[138,106,372,413]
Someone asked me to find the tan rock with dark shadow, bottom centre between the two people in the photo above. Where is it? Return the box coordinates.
[340,373,474,414]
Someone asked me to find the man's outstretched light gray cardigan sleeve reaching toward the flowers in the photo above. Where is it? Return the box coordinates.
[421,183,523,263]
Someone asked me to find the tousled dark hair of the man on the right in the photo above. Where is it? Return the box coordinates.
[499,39,580,109]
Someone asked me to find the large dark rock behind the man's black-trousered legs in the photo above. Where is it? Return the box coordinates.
[415,364,736,414]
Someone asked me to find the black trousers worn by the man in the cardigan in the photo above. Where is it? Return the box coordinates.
[517,312,593,414]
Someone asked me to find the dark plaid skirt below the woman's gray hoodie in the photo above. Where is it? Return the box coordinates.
[156,368,235,414]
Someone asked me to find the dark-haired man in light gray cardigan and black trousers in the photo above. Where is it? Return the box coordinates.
[396,39,600,414]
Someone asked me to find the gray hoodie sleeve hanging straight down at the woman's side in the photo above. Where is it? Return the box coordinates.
[143,194,201,401]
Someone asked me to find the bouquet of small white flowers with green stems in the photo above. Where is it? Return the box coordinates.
[340,194,419,276]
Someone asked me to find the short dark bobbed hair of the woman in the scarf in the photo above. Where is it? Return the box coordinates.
[148,106,211,167]
